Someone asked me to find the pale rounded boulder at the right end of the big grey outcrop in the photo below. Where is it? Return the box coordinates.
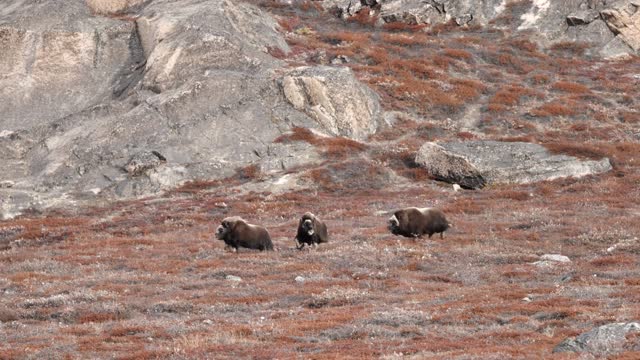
[280,66,381,139]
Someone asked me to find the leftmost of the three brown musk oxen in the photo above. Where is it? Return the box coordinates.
[216,216,273,251]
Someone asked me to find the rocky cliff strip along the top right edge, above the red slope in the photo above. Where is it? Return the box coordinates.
[323,0,640,57]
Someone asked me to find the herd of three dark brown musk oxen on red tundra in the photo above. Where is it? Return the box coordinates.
[216,207,452,252]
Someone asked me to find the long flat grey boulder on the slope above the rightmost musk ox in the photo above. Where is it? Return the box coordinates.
[416,141,611,189]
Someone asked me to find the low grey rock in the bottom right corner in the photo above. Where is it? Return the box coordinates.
[553,322,640,356]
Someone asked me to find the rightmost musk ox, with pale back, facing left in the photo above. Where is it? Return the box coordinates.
[389,207,451,239]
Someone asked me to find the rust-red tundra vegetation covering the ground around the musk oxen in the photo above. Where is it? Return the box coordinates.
[0,1,640,359]
